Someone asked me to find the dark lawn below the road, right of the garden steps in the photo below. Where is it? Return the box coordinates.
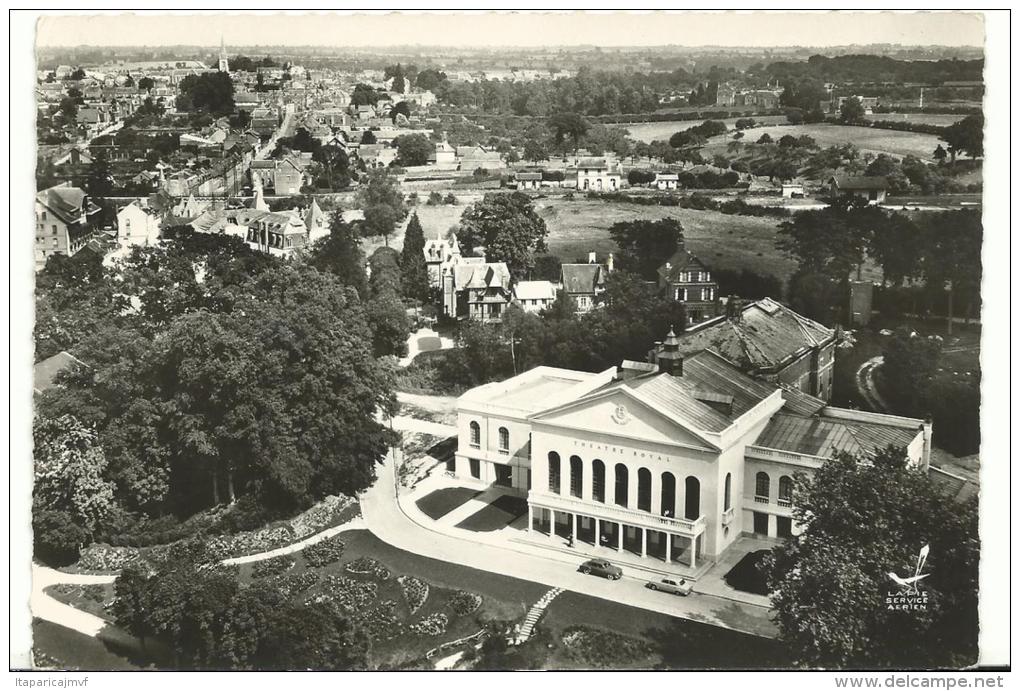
[539,592,792,670]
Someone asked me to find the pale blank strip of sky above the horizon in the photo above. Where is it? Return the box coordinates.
[37,10,984,48]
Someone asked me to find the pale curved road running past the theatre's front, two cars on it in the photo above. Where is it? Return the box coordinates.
[360,453,777,638]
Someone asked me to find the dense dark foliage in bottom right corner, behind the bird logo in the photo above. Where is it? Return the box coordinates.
[767,447,979,669]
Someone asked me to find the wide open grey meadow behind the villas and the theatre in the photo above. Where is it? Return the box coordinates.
[537,198,796,281]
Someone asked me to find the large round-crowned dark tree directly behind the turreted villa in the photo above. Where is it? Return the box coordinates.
[457,192,549,277]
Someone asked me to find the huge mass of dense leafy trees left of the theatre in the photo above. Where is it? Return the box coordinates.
[36,228,397,551]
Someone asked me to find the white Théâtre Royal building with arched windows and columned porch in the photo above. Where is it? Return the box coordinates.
[454,333,931,574]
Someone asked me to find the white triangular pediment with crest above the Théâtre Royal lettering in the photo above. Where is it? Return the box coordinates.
[531,389,717,451]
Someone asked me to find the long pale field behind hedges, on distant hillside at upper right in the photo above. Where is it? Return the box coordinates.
[703,125,939,160]
